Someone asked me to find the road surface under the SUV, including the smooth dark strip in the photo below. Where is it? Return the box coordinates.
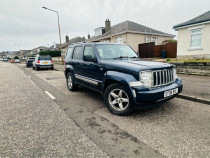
[0,63,210,157]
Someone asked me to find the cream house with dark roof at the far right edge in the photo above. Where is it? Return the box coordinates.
[173,11,210,59]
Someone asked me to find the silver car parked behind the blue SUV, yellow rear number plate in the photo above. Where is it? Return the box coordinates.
[33,55,54,71]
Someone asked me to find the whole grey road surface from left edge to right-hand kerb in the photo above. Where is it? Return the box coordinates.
[0,62,210,158]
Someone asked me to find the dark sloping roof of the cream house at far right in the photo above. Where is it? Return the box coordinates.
[173,10,210,30]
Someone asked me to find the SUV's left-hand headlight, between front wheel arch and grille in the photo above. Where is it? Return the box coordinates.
[140,71,153,87]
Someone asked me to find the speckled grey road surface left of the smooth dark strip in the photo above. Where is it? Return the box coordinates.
[0,62,108,157]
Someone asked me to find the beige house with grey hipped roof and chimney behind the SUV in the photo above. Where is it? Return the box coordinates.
[88,19,175,52]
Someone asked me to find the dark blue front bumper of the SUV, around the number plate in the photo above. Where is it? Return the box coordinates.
[132,78,183,109]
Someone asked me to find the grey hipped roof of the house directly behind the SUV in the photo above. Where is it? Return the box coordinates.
[88,20,174,41]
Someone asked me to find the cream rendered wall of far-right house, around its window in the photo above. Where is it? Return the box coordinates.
[177,23,210,59]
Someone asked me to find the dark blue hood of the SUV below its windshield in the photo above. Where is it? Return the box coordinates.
[101,59,173,72]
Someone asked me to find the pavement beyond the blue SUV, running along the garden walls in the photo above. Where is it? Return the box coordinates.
[55,64,210,105]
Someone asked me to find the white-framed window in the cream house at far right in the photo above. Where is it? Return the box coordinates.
[190,29,201,48]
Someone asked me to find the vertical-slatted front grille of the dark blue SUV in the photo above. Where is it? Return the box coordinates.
[152,69,174,87]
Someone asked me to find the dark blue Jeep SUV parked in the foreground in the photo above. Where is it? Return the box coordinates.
[64,43,182,115]
